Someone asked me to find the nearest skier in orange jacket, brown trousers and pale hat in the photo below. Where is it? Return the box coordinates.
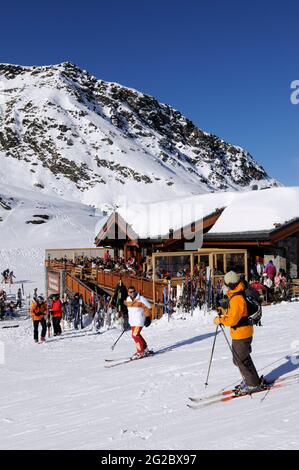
[214,271,261,393]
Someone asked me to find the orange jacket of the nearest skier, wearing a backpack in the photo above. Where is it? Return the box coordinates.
[219,282,253,339]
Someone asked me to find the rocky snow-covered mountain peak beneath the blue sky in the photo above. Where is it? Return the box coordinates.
[0,62,277,207]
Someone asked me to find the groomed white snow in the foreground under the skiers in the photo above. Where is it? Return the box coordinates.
[0,292,299,450]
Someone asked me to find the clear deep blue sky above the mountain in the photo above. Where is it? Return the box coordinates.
[0,0,299,185]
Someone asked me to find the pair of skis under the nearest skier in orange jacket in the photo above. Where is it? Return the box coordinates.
[187,374,299,410]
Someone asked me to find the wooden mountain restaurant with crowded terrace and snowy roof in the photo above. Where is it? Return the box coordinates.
[45,188,299,305]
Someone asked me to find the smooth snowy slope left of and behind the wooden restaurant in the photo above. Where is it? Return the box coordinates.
[0,184,101,291]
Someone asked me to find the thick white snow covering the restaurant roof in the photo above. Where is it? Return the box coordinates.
[97,187,299,239]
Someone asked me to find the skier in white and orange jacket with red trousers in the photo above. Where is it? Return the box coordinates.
[125,286,152,359]
